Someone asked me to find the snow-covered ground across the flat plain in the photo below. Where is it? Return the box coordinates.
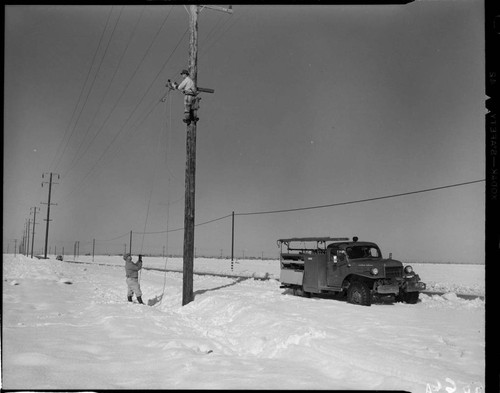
[2,255,485,392]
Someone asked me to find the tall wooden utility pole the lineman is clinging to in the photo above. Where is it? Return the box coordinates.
[182,5,233,306]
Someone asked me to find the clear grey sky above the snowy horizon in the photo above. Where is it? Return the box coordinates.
[3,0,486,263]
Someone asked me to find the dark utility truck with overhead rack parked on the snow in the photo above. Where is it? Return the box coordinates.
[278,237,425,306]
